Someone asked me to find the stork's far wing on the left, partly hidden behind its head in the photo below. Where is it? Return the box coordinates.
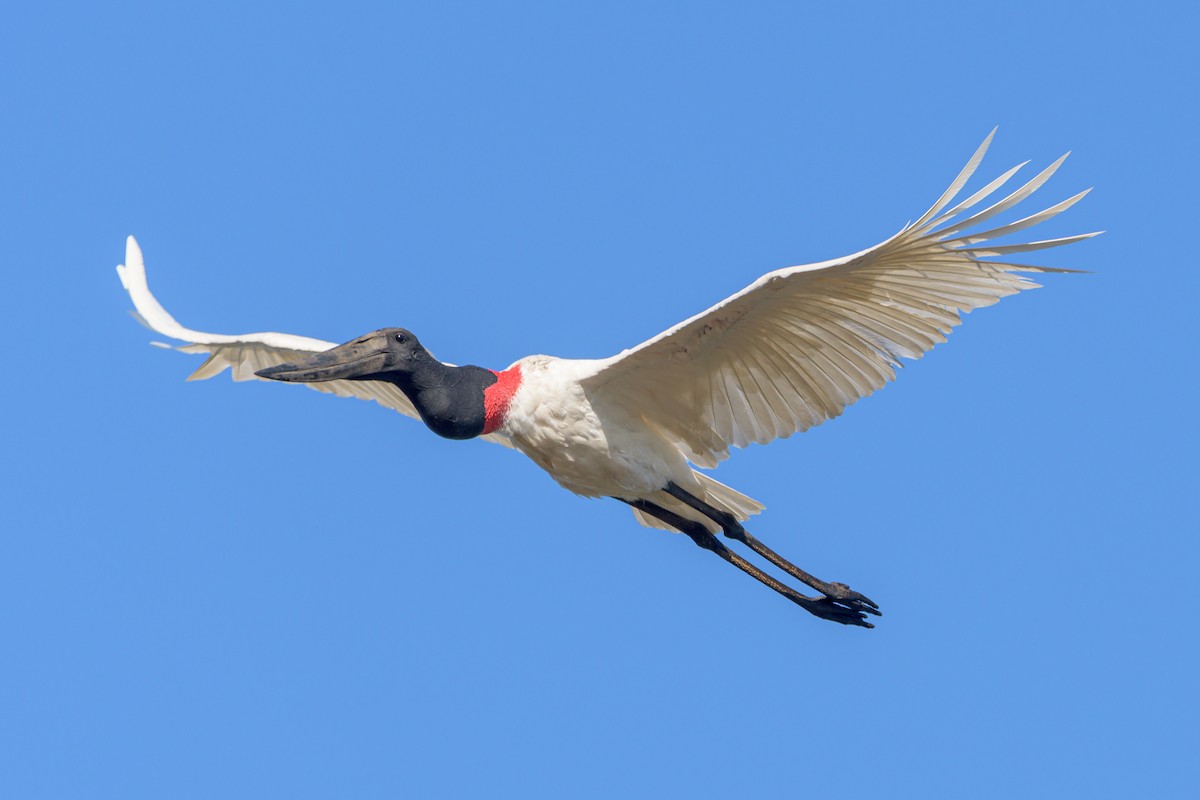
[116,236,512,447]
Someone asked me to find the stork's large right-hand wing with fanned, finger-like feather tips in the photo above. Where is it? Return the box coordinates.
[583,131,1097,467]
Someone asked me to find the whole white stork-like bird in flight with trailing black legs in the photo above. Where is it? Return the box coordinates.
[116,131,1099,627]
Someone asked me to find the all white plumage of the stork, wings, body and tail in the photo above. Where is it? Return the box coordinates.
[118,131,1096,628]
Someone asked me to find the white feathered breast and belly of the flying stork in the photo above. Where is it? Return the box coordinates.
[503,355,694,499]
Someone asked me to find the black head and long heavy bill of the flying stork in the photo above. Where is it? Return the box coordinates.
[254,327,433,383]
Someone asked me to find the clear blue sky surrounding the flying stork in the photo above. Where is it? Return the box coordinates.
[0,2,1200,798]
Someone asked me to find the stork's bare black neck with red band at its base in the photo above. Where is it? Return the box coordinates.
[389,359,521,439]
